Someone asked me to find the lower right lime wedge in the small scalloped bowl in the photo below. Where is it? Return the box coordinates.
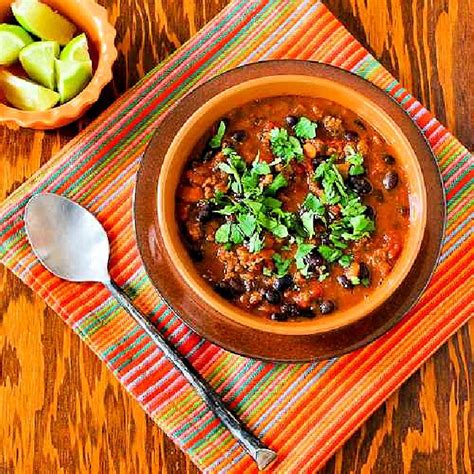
[56,59,92,104]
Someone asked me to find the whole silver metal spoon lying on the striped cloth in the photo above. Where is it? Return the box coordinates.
[25,193,276,469]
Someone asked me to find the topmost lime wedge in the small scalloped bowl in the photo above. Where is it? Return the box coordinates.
[11,0,76,45]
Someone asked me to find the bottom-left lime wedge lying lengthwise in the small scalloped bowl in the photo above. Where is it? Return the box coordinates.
[0,71,59,112]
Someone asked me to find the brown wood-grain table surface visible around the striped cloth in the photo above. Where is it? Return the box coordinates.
[0,0,474,474]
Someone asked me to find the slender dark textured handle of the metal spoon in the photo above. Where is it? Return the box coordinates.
[104,281,276,469]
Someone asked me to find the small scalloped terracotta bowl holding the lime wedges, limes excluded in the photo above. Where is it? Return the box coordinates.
[0,0,117,130]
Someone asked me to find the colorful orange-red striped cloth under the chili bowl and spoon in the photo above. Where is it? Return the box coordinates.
[0,0,473,473]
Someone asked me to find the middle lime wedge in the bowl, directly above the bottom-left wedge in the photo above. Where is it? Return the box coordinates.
[20,41,59,90]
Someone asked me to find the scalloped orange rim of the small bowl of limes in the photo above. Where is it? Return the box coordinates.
[0,0,118,130]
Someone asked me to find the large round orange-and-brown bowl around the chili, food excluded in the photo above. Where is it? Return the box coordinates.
[135,61,444,360]
